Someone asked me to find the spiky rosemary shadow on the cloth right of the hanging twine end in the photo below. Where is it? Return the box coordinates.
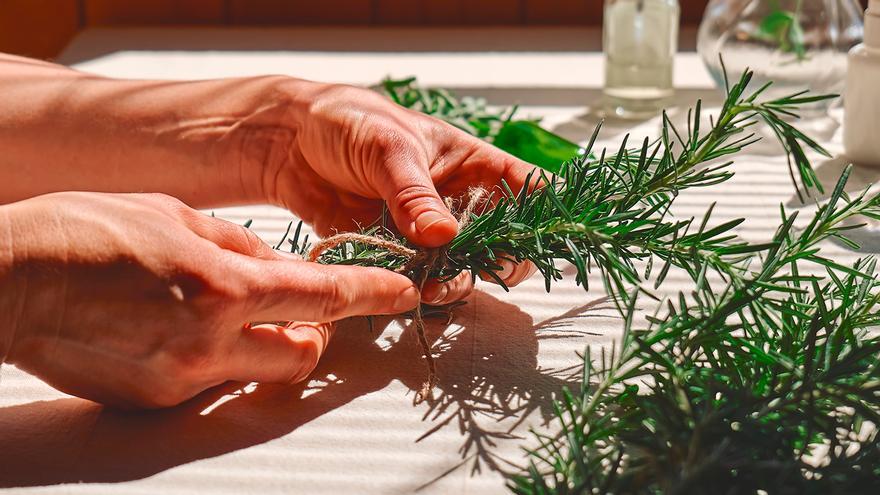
[412,292,613,486]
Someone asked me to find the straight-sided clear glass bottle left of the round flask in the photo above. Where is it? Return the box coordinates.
[602,0,681,118]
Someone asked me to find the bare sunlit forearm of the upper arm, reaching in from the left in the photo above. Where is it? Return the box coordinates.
[0,55,310,207]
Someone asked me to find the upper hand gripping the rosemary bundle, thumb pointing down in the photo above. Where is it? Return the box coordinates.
[241,81,535,304]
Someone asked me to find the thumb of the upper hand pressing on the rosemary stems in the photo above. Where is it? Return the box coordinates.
[379,162,458,247]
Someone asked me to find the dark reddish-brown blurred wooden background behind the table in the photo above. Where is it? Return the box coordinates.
[0,0,720,58]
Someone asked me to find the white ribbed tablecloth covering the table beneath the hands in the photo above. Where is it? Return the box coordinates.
[0,28,876,495]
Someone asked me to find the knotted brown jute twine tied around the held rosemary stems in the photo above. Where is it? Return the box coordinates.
[307,188,487,404]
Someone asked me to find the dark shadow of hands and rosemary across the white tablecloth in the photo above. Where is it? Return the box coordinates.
[0,291,601,487]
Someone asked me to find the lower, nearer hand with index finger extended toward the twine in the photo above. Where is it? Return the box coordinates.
[0,193,419,407]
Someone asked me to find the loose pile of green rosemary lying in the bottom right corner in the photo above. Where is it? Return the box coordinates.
[510,171,880,494]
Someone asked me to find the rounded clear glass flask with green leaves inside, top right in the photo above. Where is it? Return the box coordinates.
[697,0,864,115]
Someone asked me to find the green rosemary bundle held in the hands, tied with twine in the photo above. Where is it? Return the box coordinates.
[298,71,830,306]
